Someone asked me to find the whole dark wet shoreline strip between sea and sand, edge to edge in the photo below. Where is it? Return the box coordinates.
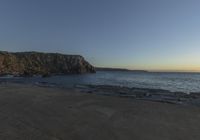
[1,82,200,106]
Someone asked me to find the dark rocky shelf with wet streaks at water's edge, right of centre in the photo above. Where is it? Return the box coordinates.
[74,85,200,106]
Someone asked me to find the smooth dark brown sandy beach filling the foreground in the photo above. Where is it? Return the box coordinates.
[0,84,200,140]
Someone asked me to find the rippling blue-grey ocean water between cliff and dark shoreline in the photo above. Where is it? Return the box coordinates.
[0,71,200,93]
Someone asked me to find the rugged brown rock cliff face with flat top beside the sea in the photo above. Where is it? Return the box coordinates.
[0,52,95,75]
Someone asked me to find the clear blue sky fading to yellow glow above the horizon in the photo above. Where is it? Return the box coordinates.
[0,0,200,72]
